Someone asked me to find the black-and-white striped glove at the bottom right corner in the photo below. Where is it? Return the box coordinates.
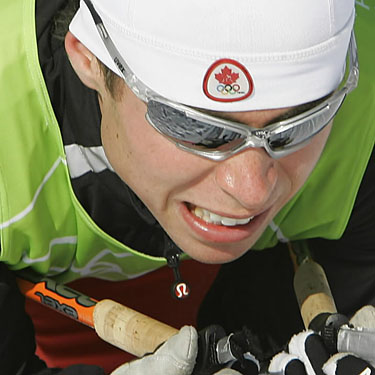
[268,306,375,375]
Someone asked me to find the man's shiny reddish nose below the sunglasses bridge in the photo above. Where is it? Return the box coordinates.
[215,149,278,211]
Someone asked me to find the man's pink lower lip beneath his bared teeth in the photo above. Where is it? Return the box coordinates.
[181,203,269,243]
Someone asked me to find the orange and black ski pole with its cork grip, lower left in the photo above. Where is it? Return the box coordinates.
[17,278,178,357]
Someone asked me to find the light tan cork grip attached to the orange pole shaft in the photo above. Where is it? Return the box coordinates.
[94,299,178,357]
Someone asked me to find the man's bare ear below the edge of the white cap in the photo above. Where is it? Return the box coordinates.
[65,31,102,91]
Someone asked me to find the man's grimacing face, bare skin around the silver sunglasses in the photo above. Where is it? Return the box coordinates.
[100,84,331,263]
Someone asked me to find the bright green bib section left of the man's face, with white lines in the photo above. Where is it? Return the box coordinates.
[0,0,166,282]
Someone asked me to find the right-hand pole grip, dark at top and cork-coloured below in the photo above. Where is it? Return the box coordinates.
[294,258,337,328]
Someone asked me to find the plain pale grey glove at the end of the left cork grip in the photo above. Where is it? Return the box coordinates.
[111,326,241,375]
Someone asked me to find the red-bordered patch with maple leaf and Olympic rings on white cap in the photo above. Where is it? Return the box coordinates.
[203,59,254,102]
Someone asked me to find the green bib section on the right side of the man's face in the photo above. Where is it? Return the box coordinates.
[254,4,375,250]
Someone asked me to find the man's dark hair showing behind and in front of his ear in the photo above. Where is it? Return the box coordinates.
[51,0,122,99]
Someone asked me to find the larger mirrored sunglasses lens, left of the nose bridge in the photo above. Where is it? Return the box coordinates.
[147,100,246,151]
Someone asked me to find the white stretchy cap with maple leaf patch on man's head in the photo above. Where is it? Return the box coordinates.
[70,0,355,111]
